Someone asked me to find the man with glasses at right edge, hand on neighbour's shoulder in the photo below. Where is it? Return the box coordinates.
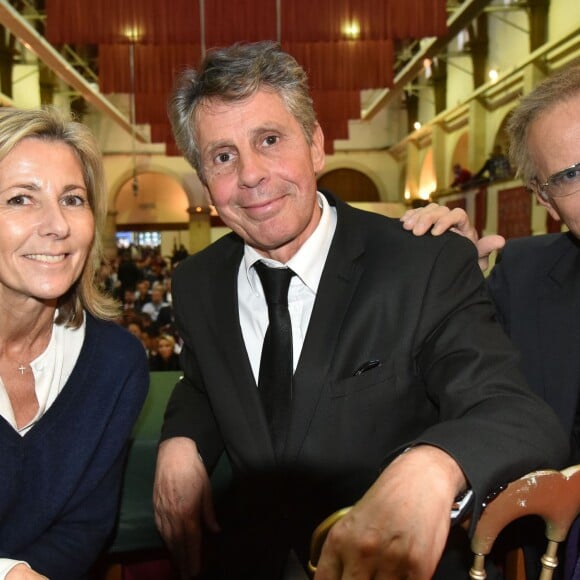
[402,65,580,577]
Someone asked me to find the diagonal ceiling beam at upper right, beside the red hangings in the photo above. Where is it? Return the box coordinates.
[361,0,491,120]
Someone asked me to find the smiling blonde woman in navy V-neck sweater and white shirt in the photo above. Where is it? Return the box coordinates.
[0,107,148,580]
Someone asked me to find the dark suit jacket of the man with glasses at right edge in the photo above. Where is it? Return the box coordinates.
[488,233,580,463]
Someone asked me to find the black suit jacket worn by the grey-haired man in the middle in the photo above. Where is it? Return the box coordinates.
[162,195,568,578]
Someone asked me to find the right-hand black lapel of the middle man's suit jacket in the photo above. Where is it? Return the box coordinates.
[285,199,364,459]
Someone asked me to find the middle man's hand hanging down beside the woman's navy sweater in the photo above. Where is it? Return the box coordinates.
[153,437,219,578]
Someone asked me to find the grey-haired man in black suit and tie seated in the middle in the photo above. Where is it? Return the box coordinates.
[154,42,568,580]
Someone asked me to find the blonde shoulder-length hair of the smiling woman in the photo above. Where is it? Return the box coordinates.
[0,107,119,328]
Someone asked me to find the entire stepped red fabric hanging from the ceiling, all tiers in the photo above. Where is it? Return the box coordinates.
[46,0,447,153]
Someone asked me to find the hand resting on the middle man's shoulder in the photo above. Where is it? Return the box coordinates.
[401,203,505,272]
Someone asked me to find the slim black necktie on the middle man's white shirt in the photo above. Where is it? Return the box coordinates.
[254,262,294,455]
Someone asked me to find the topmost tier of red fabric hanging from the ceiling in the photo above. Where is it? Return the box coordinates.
[46,0,447,47]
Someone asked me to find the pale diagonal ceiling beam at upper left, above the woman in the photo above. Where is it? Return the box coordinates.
[0,0,151,143]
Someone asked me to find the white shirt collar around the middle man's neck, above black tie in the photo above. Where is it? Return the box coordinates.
[244,192,336,293]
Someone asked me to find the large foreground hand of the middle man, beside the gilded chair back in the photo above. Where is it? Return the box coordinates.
[315,445,466,580]
